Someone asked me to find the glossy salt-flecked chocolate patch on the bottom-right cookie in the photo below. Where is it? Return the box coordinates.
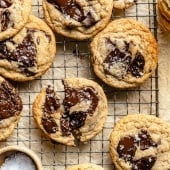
[117,130,158,170]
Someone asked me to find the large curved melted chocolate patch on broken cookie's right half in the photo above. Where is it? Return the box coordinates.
[60,81,99,135]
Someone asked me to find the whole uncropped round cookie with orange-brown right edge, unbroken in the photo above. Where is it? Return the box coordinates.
[91,18,158,89]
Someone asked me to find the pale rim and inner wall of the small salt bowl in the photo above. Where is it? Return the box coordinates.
[0,146,43,170]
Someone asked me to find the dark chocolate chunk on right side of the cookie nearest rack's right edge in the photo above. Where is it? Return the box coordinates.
[129,53,145,77]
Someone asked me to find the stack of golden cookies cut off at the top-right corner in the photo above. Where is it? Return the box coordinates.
[158,0,170,32]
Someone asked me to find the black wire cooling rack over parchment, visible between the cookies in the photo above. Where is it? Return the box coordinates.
[0,0,159,170]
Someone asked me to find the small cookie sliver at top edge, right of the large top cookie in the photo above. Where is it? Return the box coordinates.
[113,0,136,9]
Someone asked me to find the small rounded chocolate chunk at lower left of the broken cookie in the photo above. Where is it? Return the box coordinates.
[42,116,58,133]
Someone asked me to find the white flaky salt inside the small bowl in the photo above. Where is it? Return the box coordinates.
[0,152,36,170]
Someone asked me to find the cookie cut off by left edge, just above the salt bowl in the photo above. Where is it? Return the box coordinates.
[0,77,22,141]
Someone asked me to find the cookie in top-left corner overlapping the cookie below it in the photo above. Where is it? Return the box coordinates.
[0,0,32,41]
